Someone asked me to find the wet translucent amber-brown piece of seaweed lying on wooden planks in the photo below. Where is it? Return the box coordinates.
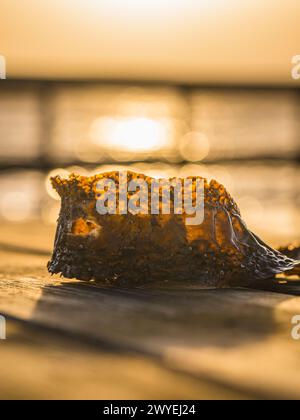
[48,172,300,287]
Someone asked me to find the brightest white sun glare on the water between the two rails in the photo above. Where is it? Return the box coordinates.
[90,117,170,153]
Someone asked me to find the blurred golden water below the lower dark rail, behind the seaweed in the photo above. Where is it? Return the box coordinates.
[0,162,300,245]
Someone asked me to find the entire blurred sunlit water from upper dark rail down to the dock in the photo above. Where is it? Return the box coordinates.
[0,82,300,244]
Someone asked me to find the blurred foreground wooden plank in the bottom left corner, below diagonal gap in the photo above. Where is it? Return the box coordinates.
[0,321,249,400]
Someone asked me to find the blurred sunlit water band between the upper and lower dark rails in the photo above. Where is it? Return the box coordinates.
[0,82,300,164]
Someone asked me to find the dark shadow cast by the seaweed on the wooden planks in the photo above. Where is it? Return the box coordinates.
[32,281,300,355]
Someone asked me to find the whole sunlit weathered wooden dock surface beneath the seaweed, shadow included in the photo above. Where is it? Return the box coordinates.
[0,223,300,399]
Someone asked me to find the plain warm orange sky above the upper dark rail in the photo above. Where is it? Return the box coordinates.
[0,0,300,85]
